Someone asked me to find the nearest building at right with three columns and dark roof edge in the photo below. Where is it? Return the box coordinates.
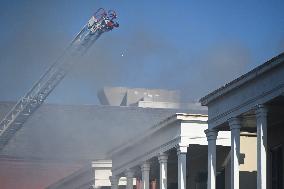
[200,53,284,189]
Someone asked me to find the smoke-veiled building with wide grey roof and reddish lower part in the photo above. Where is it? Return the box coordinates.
[0,88,200,189]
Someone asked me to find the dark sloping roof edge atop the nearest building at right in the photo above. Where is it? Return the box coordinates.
[200,53,284,106]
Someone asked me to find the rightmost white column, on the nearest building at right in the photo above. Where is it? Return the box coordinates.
[255,105,267,189]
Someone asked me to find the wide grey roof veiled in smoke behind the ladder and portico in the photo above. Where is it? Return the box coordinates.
[0,102,207,161]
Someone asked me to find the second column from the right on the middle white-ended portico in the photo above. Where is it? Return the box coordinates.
[158,153,168,189]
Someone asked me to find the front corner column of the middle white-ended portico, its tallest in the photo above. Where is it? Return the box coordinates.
[177,146,187,189]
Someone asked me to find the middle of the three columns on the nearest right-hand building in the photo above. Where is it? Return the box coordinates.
[228,118,241,189]
